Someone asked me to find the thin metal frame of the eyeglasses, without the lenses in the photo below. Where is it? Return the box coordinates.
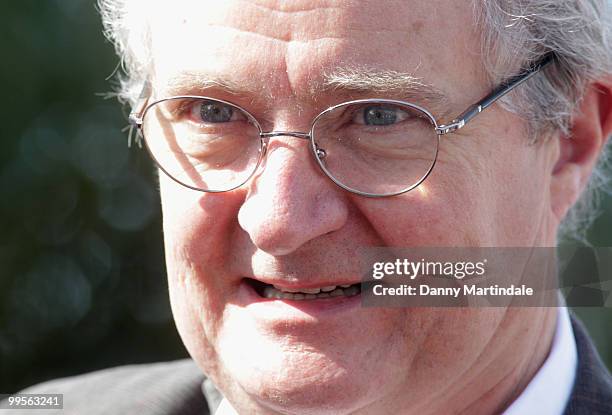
[129,53,555,198]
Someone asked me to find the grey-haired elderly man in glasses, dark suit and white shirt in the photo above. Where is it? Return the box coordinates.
[5,0,612,414]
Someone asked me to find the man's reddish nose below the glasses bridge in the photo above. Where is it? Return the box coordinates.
[238,133,348,256]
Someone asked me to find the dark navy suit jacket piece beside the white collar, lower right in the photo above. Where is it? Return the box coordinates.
[564,315,612,415]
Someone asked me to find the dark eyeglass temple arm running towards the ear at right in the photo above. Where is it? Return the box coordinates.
[436,53,555,135]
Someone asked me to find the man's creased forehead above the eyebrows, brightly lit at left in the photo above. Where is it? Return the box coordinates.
[150,0,483,107]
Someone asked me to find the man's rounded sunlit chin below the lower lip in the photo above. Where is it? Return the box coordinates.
[217,316,380,414]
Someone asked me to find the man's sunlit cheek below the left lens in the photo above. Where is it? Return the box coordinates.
[160,174,245,373]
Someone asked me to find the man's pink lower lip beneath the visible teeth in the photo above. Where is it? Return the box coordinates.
[238,281,361,319]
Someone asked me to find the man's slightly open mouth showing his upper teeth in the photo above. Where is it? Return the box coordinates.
[246,278,361,301]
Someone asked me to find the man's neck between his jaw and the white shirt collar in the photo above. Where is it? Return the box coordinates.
[359,307,558,415]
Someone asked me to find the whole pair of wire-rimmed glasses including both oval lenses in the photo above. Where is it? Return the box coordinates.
[130,55,553,197]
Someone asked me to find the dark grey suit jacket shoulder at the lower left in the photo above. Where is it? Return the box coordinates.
[0,359,209,415]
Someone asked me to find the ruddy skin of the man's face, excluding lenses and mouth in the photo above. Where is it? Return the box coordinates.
[151,0,555,413]
